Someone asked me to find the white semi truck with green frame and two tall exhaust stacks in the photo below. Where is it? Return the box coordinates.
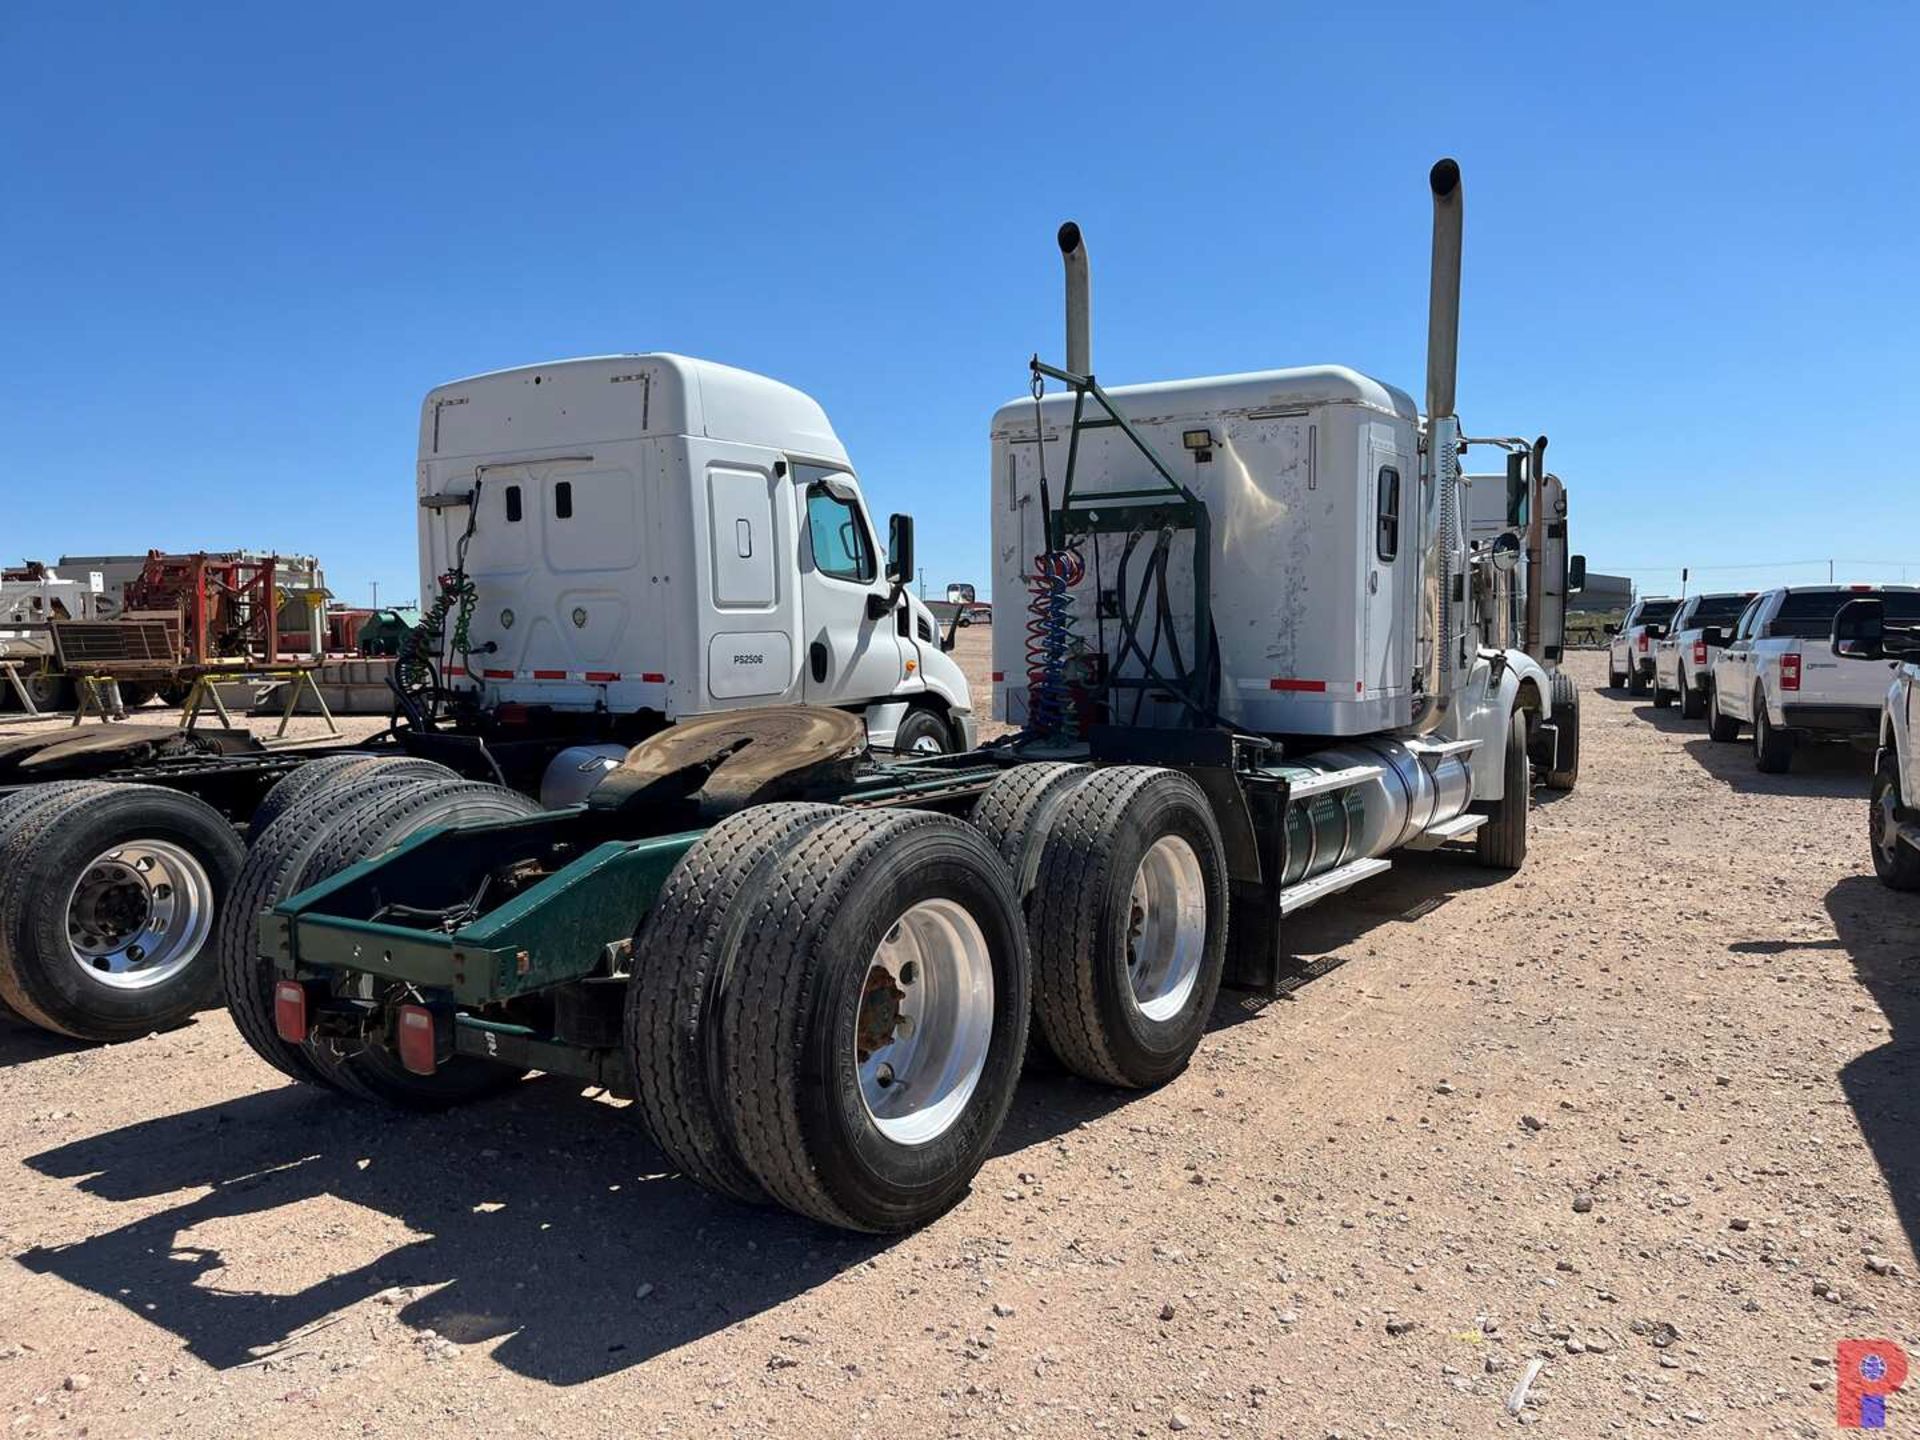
[243,161,1551,1231]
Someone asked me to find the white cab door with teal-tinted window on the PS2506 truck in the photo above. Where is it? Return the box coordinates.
[791,461,918,707]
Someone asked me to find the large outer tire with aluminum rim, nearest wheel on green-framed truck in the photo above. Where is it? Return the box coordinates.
[718,810,1029,1233]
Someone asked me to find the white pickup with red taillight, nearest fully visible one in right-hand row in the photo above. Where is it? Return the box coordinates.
[1707,586,1920,774]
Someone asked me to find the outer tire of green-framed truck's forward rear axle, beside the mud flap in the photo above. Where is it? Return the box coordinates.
[1027,766,1227,1089]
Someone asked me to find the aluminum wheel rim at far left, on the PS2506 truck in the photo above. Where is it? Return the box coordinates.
[65,839,215,991]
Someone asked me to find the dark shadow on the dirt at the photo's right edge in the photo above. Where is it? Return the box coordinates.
[1826,875,1920,1250]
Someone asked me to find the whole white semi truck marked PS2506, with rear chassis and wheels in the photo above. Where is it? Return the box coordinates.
[0,355,975,1041]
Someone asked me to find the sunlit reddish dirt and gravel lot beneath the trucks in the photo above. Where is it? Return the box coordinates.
[0,655,1920,1438]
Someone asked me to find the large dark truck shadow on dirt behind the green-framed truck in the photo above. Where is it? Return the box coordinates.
[15,1036,1136,1384]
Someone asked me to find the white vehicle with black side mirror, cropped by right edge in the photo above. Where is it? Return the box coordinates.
[1832,597,1920,891]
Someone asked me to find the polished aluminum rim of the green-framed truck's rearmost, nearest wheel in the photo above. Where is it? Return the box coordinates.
[854,900,993,1144]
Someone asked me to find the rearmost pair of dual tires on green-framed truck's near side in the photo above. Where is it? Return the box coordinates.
[628,804,1031,1233]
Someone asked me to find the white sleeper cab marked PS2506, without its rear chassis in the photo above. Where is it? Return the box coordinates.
[419,355,975,768]
